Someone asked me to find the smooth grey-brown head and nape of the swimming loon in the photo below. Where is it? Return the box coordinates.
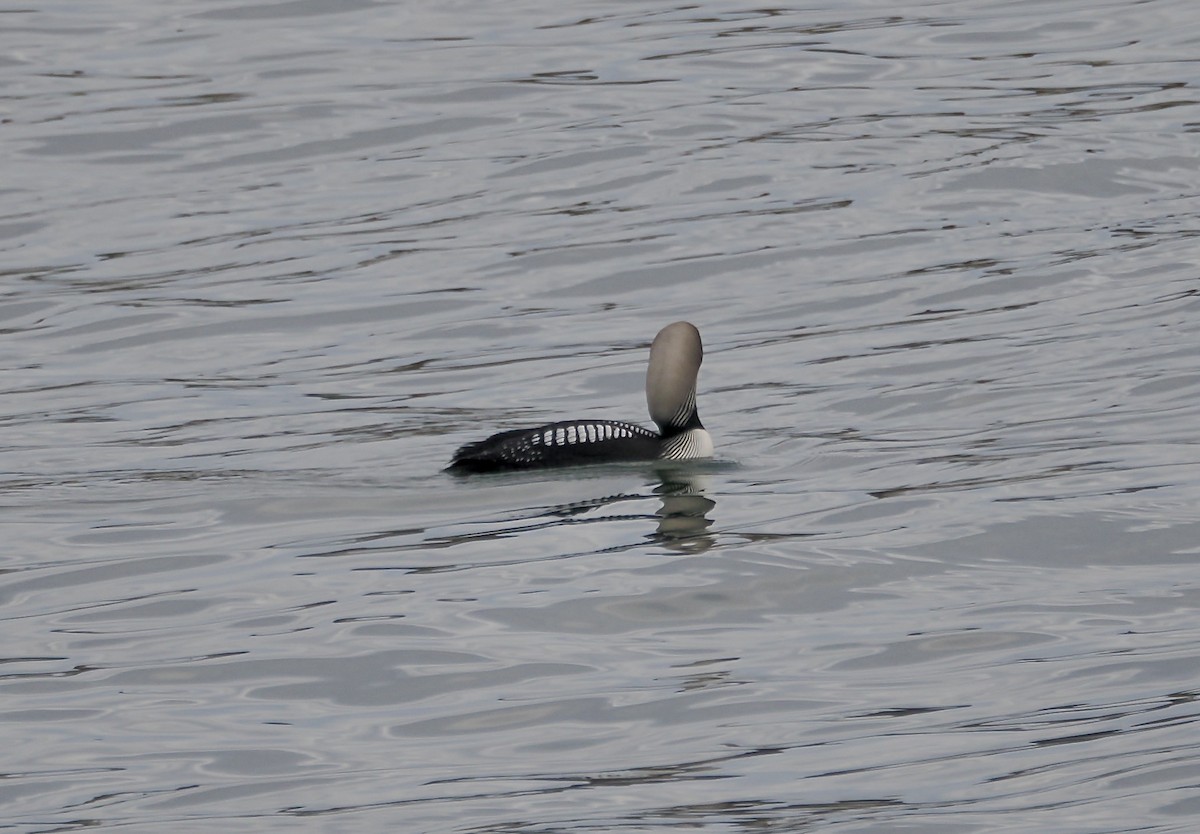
[646,322,704,436]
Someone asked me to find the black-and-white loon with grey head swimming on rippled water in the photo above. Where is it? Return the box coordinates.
[450,322,713,473]
